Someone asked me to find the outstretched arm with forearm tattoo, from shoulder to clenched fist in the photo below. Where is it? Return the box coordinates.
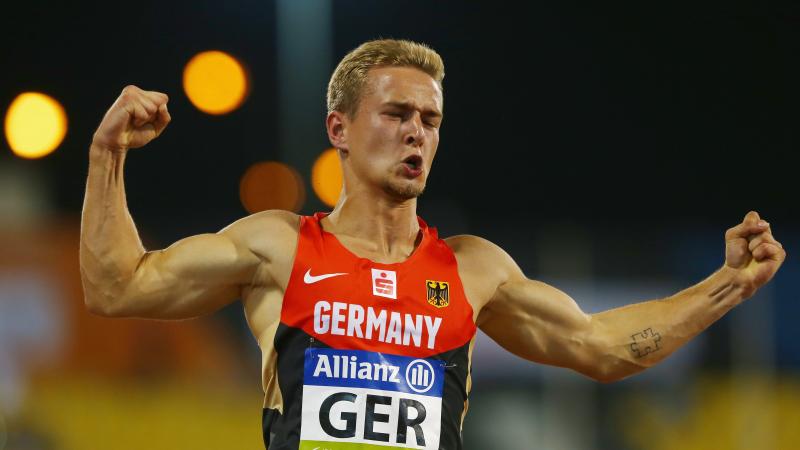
[478,212,786,382]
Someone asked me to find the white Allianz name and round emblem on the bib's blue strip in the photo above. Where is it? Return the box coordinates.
[314,354,436,394]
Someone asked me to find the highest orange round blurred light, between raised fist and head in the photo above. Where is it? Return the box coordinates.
[183,50,248,114]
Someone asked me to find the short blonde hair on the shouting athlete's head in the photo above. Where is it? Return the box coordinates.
[327,39,444,118]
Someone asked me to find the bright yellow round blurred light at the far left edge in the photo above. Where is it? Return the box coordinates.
[5,92,67,159]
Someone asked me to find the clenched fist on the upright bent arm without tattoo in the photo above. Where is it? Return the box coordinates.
[92,85,171,151]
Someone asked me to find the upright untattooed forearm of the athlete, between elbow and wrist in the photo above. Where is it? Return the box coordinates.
[80,145,145,312]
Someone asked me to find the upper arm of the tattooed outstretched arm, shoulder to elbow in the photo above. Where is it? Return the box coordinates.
[479,271,592,375]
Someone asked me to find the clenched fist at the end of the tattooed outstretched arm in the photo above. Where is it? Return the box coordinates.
[725,211,786,297]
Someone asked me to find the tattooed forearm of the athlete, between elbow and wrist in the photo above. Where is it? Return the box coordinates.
[592,267,750,381]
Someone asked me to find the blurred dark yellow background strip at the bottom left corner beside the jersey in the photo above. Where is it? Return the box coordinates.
[8,375,264,450]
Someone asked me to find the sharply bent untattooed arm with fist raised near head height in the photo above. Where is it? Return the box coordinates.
[80,86,270,319]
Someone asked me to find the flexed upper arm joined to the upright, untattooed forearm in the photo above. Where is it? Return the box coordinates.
[115,230,259,319]
